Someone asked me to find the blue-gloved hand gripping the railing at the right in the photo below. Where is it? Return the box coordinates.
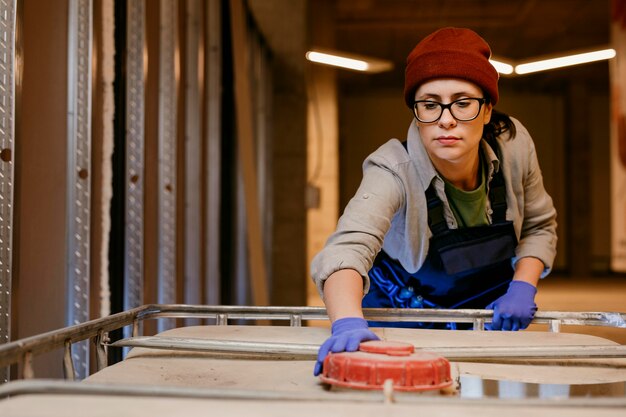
[485,281,537,331]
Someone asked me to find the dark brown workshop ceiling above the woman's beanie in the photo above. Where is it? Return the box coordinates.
[326,0,610,90]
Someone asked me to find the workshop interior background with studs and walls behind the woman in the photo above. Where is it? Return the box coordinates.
[0,0,626,377]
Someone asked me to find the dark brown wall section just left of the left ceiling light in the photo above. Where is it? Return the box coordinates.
[248,0,308,305]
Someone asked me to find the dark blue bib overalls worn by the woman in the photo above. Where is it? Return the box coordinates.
[362,141,517,329]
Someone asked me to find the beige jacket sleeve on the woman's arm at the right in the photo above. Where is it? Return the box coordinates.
[513,123,557,278]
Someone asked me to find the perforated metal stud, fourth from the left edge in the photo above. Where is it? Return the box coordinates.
[158,0,177,331]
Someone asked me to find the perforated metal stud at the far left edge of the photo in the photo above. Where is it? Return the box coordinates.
[0,0,15,383]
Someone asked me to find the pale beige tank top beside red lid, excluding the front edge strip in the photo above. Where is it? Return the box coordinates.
[87,326,626,386]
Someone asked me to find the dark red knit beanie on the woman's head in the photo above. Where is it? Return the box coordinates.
[404,28,498,108]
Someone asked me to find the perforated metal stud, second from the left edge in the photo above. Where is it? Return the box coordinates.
[67,0,92,379]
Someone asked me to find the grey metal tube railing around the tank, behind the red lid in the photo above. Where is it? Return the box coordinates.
[0,304,626,378]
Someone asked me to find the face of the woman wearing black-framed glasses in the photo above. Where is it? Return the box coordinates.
[415,78,492,165]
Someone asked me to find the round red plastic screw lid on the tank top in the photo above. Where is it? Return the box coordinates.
[320,340,452,391]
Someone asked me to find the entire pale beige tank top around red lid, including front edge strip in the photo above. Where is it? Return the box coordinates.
[0,326,626,417]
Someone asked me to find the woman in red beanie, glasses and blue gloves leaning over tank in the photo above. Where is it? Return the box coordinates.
[311,28,556,375]
